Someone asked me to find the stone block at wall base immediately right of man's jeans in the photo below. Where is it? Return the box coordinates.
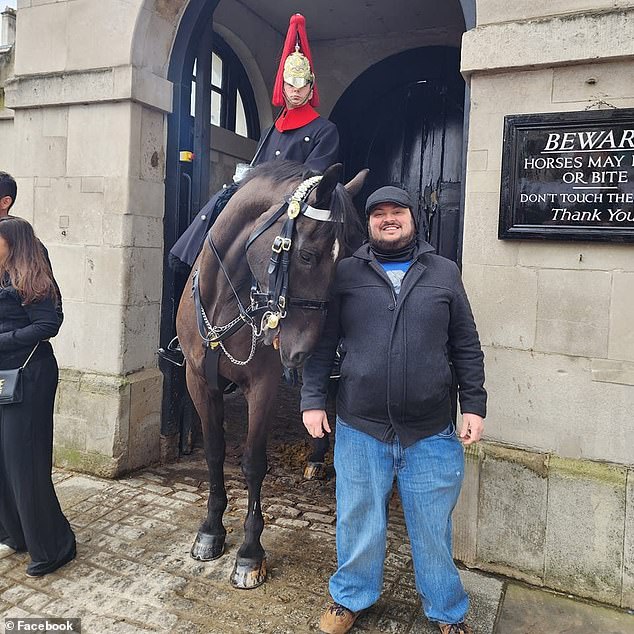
[477,445,548,584]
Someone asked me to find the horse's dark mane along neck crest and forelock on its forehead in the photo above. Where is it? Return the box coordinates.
[240,161,363,252]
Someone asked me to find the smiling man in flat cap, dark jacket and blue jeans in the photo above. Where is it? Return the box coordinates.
[301,187,486,634]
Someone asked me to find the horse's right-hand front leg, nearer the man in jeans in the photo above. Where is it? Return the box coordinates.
[231,367,280,590]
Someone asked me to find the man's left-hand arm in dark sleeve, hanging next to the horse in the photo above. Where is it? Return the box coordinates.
[300,286,340,438]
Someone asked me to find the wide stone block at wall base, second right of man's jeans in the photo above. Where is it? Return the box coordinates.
[545,456,627,605]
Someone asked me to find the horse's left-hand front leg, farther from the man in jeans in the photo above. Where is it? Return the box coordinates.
[187,366,227,561]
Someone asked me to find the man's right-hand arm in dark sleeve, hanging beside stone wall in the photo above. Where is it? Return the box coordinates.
[449,260,487,445]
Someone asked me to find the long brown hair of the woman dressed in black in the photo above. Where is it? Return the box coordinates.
[0,216,57,304]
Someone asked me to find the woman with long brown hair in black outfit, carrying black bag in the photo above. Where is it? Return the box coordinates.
[0,216,75,577]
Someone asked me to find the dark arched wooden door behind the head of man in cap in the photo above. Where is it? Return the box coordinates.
[331,47,464,262]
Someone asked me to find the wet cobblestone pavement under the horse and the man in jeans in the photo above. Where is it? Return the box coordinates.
[0,388,634,634]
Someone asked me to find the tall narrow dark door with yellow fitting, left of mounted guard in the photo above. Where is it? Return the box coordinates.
[159,7,217,458]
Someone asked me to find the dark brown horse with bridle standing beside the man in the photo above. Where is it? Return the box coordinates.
[176,162,367,588]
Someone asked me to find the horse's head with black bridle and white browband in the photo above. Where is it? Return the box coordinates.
[247,164,368,368]
